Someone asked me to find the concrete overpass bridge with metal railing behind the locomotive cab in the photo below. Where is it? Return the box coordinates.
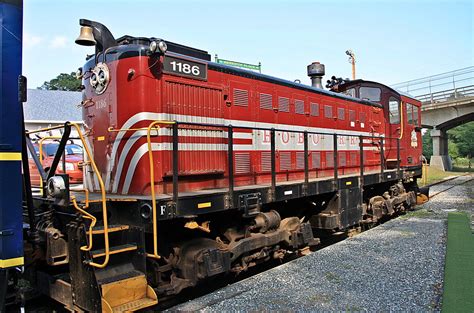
[392,66,474,170]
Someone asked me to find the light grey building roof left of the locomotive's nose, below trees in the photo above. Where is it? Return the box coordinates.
[23,89,82,122]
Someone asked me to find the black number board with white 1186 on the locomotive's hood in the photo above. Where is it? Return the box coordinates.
[163,56,207,80]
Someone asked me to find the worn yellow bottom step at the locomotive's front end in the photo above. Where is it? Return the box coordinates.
[101,271,158,312]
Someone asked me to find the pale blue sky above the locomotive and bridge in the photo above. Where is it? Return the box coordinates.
[23,0,474,88]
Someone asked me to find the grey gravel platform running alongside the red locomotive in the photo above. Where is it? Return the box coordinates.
[170,176,474,312]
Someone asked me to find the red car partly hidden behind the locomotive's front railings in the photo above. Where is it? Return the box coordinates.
[28,142,84,187]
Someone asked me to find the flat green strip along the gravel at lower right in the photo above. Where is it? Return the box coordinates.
[442,212,474,312]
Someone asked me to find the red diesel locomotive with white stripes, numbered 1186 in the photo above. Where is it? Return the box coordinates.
[22,20,422,312]
